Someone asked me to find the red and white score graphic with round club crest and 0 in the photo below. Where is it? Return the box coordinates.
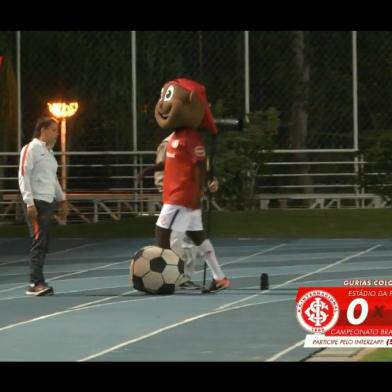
[296,280,392,348]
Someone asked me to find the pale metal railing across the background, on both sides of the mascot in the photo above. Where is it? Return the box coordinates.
[0,150,386,224]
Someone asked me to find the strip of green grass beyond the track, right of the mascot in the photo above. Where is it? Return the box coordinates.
[212,209,392,238]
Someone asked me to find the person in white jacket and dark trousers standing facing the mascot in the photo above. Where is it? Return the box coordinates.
[18,117,68,296]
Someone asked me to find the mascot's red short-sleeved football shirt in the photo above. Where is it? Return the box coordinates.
[163,128,206,210]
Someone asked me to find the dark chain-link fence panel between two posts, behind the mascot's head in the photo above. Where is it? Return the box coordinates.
[137,31,244,150]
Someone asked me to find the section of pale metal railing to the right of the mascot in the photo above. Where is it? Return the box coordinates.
[255,149,387,209]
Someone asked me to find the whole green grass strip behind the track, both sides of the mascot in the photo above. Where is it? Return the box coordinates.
[0,209,392,238]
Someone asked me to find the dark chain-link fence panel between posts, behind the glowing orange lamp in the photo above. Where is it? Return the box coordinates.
[21,31,132,151]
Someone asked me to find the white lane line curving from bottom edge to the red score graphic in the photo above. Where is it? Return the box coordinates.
[78,298,292,362]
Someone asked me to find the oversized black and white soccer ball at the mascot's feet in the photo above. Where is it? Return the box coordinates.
[130,245,184,294]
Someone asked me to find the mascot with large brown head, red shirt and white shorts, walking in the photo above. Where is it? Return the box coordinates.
[153,79,230,292]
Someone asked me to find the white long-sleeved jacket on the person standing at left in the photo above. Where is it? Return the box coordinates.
[19,138,65,206]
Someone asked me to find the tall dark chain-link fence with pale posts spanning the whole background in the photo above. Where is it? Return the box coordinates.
[0,31,392,219]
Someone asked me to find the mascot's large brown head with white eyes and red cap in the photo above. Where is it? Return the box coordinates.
[155,79,217,134]
